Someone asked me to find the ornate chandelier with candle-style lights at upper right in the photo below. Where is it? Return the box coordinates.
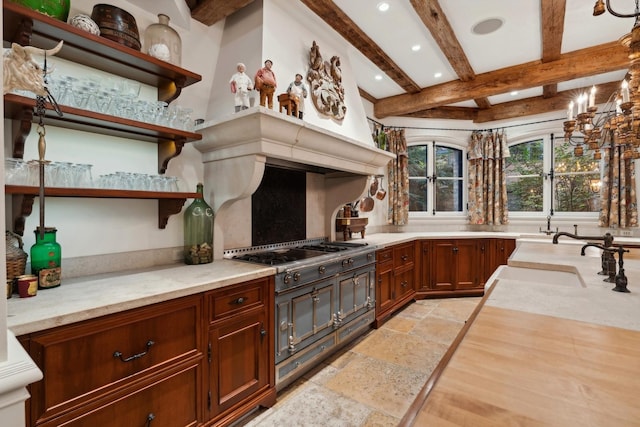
[564,0,640,160]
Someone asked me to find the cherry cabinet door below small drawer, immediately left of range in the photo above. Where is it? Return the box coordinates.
[209,311,270,418]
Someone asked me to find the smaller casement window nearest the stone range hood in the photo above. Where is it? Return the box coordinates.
[408,143,464,214]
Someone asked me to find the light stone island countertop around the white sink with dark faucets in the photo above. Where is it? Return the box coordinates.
[485,240,640,331]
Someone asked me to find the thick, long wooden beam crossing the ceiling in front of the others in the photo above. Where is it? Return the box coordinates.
[374,42,629,118]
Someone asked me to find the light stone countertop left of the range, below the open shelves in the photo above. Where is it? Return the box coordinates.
[7,260,275,336]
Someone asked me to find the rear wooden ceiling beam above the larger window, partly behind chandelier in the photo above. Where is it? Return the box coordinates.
[474,82,620,123]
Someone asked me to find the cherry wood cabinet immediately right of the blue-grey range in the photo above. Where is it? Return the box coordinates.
[374,242,417,328]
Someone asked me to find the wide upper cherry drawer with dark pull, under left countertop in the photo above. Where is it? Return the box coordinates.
[31,297,202,419]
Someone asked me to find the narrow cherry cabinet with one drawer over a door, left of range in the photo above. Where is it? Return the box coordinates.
[205,278,276,425]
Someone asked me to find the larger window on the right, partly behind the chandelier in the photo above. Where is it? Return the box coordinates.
[505,136,600,213]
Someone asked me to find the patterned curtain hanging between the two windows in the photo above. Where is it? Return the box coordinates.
[469,130,509,225]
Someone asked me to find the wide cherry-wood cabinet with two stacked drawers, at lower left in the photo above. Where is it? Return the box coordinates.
[24,296,203,426]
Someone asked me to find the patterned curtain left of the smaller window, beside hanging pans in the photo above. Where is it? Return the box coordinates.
[386,129,409,225]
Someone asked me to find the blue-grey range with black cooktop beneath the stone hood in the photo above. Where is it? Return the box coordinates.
[225,240,375,389]
